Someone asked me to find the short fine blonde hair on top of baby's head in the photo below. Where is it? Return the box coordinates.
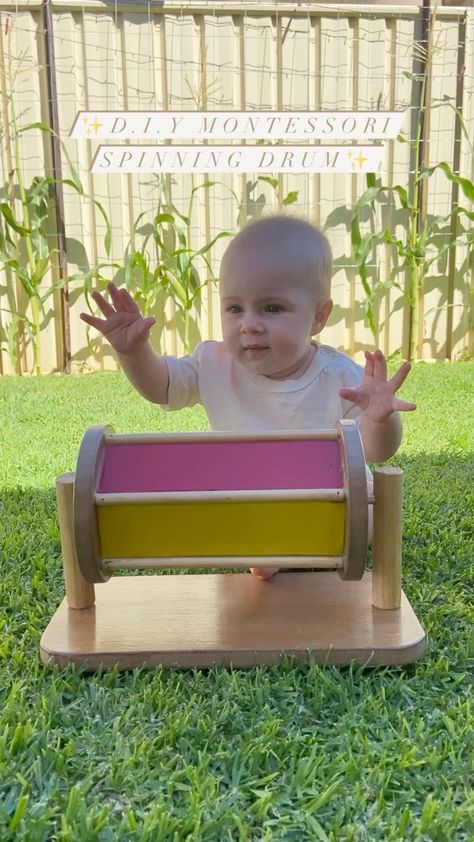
[221,214,332,303]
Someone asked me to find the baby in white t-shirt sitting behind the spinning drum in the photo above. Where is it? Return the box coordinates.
[81,216,416,579]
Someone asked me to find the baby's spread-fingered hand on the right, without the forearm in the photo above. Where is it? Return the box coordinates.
[339,351,416,423]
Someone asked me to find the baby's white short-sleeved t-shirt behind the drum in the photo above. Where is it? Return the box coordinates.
[163,341,363,432]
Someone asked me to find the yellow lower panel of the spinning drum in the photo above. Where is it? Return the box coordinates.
[98,500,345,558]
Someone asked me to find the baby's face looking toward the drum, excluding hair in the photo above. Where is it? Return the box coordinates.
[220,248,324,380]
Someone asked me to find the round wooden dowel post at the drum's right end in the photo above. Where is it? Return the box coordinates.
[372,467,402,609]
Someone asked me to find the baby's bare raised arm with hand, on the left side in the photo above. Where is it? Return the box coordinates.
[81,283,169,404]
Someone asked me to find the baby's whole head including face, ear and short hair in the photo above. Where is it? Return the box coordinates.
[220,216,332,379]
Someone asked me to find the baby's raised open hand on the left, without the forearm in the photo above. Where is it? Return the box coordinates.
[81,283,155,354]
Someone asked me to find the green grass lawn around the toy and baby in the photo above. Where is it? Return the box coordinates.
[0,363,474,842]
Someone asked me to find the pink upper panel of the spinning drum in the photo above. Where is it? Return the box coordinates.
[97,439,343,493]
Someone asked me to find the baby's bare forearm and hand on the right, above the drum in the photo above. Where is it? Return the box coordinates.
[339,351,416,462]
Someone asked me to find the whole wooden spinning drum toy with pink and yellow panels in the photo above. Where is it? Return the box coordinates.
[41,421,425,669]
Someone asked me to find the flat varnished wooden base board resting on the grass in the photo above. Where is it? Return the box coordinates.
[40,571,425,670]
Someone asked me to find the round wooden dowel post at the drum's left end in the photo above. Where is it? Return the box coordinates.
[56,473,95,608]
